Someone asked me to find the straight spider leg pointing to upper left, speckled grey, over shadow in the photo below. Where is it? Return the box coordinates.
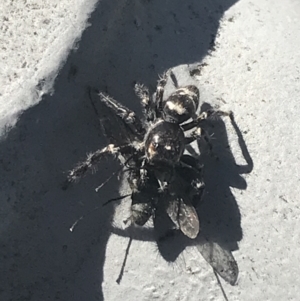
[99,92,145,140]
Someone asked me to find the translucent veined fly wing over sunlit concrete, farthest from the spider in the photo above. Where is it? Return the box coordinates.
[197,238,239,285]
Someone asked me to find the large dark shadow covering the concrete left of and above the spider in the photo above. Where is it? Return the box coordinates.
[0,0,241,301]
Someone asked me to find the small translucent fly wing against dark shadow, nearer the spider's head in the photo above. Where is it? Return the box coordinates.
[166,197,200,239]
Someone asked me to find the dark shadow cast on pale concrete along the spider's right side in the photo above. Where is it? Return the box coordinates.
[191,103,253,250]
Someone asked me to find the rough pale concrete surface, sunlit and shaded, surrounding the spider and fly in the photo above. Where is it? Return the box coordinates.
[0,0,300,301]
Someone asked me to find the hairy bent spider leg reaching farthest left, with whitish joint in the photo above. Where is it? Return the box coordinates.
[68,144,134,182]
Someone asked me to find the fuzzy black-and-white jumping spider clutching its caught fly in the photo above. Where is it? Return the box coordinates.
[68,71,232,239]
